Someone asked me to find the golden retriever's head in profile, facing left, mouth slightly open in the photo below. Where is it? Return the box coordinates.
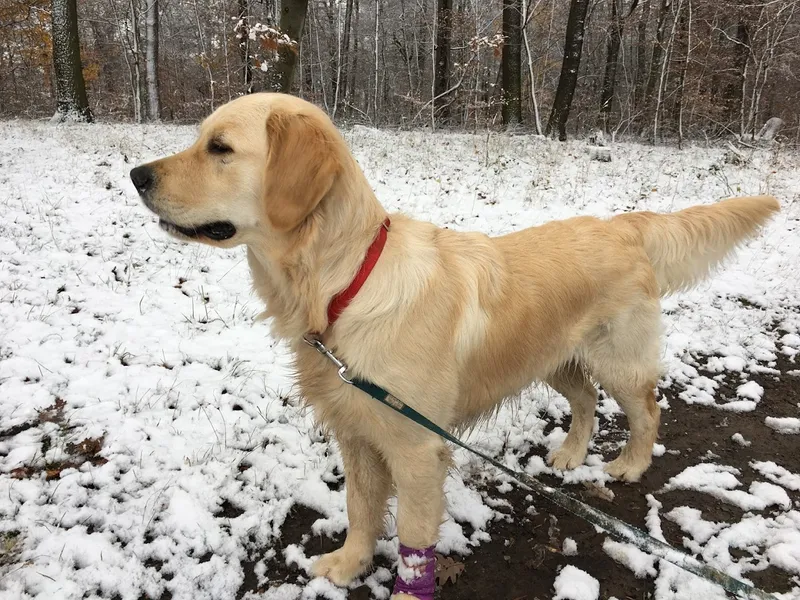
[130,93,347,247]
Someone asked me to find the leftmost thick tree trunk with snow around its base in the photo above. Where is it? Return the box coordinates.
[52,0,93,123]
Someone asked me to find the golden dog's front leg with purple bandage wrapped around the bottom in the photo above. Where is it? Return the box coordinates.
[389,436,450,600]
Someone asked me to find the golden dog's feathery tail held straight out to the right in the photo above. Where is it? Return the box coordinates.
[612,196,780,296]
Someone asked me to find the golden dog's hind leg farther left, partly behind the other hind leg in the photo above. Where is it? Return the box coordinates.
[546,362,597,471]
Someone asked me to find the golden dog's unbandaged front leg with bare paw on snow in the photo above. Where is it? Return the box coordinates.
[311,439,391,586]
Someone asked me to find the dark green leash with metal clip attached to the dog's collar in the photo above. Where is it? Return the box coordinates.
[303,336,777,600]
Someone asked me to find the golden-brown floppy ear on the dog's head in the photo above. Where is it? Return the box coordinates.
[264,110,342,231]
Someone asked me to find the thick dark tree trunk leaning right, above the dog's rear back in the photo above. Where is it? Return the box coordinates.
[545,0,589,142]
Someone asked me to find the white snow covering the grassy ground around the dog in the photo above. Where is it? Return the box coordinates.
[0,122,800,600]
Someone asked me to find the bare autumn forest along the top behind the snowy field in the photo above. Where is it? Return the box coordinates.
[0,0,800,143]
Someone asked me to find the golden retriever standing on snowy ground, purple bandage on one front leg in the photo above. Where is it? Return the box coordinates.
[131,93,779,599]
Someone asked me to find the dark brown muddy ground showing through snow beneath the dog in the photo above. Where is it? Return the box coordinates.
[245,350,800,600]
